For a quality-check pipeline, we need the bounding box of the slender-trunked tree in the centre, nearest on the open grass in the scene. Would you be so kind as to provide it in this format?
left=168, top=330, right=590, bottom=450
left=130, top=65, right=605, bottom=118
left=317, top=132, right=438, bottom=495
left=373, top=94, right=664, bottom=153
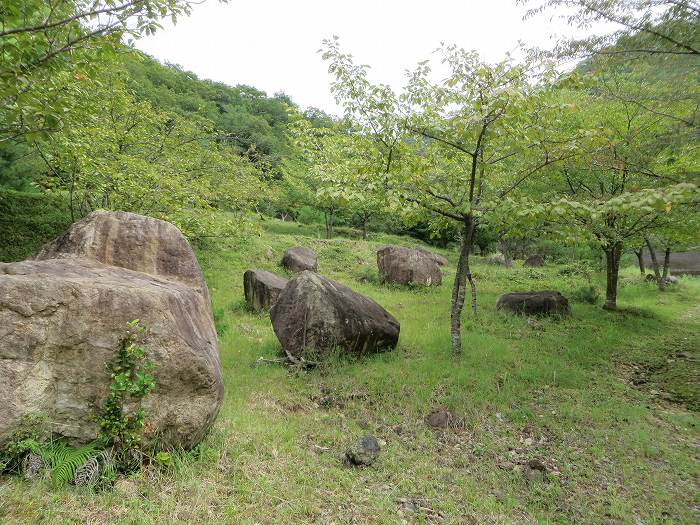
left=324, top=39, right=575, bottom=353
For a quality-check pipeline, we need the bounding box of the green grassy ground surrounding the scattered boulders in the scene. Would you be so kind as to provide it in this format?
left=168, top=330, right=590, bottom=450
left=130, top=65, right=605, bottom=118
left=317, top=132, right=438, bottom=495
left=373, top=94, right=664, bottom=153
left=0, top=216, right=700, bottom=525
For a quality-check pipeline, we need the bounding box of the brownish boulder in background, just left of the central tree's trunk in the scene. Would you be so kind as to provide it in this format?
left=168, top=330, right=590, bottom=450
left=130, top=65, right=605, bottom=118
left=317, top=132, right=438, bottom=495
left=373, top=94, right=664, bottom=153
left=377, top=246, right=442, bottom=286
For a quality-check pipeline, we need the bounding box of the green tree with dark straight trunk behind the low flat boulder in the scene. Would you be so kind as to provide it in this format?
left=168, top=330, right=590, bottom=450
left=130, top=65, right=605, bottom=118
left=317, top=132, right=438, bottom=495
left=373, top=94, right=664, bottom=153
left=502, top=78, right=698, bottom=310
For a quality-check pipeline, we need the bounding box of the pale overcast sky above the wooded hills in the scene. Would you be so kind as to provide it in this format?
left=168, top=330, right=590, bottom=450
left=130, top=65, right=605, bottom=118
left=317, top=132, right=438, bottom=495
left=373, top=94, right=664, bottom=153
left=137, top=0, right=571, bottom=114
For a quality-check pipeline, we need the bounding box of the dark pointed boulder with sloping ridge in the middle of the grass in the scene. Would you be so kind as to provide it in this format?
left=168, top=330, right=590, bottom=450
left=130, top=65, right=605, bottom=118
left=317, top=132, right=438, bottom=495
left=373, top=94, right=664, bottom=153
left=270, top=271, right=400, bottom=356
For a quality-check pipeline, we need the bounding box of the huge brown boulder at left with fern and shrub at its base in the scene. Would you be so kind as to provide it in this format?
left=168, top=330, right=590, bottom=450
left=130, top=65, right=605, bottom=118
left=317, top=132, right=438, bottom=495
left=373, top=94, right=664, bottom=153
left=0, top=212, right=223, bottom=448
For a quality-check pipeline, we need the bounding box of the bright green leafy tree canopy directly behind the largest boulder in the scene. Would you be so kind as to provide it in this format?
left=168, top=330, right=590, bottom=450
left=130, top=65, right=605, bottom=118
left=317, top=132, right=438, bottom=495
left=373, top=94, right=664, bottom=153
left=33, top=62, right=263, bottom=236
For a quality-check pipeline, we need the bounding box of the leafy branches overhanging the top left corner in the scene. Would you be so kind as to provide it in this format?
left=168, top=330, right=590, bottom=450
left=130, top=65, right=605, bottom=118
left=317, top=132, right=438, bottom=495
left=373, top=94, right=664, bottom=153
left=0, top=0, right=202, bottom=142
